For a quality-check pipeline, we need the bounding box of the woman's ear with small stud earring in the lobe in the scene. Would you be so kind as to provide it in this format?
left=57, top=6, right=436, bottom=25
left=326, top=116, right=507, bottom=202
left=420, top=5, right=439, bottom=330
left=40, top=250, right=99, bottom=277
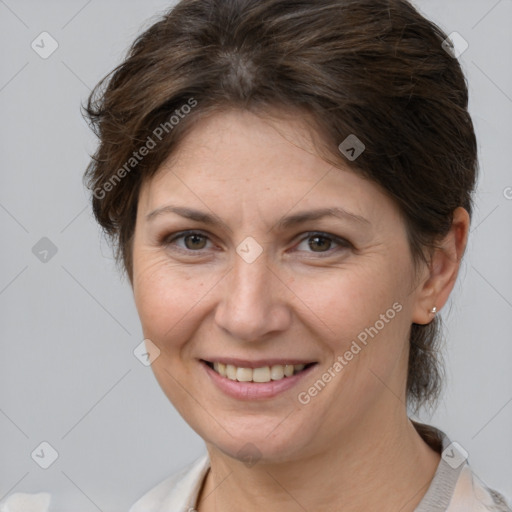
left=412, top=207, right=469, bottom=324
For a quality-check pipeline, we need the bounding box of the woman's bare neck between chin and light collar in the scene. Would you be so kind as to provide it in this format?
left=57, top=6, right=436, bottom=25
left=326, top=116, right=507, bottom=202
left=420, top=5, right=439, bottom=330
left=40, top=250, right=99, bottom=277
left=197, top=408, right=440, bottom=512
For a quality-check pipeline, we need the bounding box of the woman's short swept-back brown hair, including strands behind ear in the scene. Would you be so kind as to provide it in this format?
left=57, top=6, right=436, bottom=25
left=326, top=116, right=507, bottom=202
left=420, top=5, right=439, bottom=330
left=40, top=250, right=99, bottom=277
left=85, top=0, right=477, bottom=410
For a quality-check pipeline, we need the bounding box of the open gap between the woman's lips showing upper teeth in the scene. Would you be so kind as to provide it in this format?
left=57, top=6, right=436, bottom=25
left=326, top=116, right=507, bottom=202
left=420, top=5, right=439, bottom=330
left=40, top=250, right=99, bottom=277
left=202, top=360, right=317, bottom=383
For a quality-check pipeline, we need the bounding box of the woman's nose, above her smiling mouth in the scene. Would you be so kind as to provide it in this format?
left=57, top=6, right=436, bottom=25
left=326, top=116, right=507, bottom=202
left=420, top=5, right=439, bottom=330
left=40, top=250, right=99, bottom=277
left=215, top=252, right=292, bottom=341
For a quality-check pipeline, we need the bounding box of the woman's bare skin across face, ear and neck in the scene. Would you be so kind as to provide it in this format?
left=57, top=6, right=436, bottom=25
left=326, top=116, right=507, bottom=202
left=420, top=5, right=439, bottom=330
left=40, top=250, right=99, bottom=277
left=132, top=110, right=469, bottom=512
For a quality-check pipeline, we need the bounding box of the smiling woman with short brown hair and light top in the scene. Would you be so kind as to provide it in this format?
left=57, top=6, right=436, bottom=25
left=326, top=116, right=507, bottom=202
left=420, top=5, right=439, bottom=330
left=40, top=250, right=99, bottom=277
left=80, top=0, right=511, bottom=512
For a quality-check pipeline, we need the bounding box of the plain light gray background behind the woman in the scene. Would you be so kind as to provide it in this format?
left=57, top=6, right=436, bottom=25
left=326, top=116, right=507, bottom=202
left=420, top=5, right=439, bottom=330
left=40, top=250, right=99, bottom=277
left=0, top=0, right=512, bottom=512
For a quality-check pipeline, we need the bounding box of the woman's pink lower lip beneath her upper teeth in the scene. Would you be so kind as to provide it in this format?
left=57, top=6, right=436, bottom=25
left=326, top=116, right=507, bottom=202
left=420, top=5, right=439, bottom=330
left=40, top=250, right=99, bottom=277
left=200, top=362, right=316, bottom=400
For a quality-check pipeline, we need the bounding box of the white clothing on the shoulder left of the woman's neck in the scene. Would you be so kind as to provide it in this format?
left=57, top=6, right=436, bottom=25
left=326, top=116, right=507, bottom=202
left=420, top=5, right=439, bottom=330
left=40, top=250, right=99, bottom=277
left=129, top=455, right=209, bottom=512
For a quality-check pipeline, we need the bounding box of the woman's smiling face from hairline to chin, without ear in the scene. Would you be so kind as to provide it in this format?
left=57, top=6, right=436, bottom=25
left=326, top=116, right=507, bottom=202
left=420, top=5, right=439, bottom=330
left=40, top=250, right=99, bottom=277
left=133, top=111, right=424, bottom=461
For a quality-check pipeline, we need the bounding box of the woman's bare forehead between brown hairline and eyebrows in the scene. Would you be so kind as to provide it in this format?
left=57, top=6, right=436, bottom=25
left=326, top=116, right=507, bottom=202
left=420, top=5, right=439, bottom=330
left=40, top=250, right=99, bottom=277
left=135, top=110, right=393, bottom=228
